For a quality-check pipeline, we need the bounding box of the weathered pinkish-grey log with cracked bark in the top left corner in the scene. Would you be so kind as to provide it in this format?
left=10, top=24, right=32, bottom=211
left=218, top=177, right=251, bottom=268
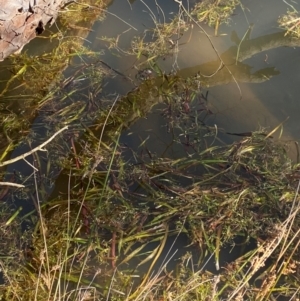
left=0, top=0, right=70, bottom=61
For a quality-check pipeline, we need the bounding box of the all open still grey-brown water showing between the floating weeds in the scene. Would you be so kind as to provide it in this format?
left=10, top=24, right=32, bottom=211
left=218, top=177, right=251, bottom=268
left=2, top=0, right=300, bottom=296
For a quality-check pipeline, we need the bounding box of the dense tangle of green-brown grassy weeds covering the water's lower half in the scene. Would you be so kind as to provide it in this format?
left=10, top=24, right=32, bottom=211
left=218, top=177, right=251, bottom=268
left=2, top=79, right=300, bottom=301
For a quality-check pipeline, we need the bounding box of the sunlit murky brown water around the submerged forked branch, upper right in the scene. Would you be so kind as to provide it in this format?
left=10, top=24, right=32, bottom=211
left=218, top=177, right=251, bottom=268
left=102, top=3, right=299, bottom=158
